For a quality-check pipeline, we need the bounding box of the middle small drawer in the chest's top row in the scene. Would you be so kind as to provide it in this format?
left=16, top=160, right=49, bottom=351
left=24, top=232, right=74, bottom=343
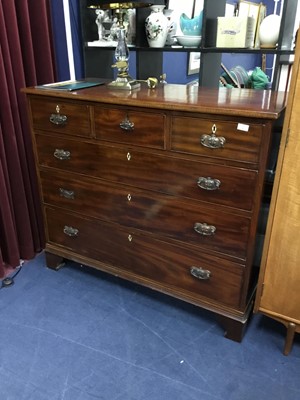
left=94, top=107, right=166, bottom=149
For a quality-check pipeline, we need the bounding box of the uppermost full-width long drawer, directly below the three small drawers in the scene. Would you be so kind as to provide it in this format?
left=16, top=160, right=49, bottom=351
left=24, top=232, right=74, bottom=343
left=36, top=135, right=257, bottom=210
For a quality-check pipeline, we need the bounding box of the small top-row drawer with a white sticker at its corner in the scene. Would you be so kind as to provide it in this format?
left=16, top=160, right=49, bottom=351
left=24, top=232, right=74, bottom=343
left=171, top=117, right=262, bottom=163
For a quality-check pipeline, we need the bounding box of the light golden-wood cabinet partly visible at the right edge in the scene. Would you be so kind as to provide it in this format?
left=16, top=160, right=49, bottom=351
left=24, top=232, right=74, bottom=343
left=255, top=35, right=300, bottom=355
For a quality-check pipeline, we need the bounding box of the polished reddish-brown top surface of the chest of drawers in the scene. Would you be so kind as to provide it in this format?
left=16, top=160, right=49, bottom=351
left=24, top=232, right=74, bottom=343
left=26, top=84, right=286, bottom=119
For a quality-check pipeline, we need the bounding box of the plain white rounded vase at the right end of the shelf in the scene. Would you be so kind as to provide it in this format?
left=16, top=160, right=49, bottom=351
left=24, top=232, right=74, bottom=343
left=259, top=14, right=281, bottom=48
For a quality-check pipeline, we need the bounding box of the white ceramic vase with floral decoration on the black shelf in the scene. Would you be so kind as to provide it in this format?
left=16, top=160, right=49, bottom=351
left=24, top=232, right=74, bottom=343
left=145, top=5, right=169, bottom=47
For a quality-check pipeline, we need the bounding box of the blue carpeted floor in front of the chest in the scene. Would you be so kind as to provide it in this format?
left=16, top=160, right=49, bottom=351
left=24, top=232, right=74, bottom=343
left=0, top=254, right=300, bottom=400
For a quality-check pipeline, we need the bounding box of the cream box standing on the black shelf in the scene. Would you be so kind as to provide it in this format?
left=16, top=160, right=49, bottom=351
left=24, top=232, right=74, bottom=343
left=216, top=17, right=255, bottom=48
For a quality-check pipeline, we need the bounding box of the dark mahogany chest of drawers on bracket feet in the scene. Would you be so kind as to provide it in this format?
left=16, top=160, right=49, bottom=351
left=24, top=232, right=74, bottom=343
left=25, top=85, right=285, bottom=341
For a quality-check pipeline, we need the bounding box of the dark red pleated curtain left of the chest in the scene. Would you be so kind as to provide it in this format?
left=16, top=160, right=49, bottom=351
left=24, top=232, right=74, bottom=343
left=0, top=0, right=55, bottom=278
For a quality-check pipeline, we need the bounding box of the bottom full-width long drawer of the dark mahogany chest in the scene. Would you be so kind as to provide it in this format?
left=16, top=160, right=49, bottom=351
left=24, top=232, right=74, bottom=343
left=46, top=208, right=244, bottom=307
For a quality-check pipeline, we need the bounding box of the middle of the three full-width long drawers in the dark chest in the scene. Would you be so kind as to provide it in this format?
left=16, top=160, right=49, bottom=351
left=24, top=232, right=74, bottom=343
left=41, top=172, right=250, bottom=259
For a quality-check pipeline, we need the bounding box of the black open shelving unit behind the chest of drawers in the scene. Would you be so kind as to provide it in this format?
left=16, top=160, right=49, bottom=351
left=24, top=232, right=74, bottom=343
left=81, top=0, right=298, bottom=90
